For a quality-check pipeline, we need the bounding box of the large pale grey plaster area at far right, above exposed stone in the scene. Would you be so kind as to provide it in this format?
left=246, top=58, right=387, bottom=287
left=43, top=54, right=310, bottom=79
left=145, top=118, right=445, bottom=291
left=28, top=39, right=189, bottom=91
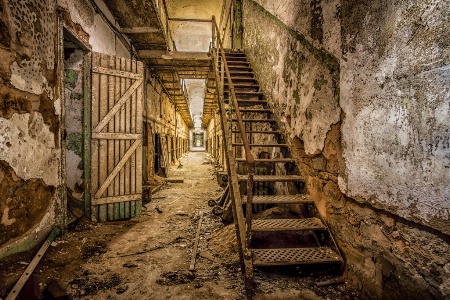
left=339, top=1, right=450, bottom=234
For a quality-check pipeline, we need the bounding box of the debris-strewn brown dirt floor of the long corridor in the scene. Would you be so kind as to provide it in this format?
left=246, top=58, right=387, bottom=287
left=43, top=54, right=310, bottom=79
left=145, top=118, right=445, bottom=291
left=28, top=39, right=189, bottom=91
left=0, top=152, right=361, bottom=300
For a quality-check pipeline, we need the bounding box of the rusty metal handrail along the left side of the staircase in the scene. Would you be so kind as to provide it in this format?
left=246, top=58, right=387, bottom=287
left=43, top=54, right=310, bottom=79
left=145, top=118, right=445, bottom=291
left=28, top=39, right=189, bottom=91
left=211, top=16, right=255, bottom=295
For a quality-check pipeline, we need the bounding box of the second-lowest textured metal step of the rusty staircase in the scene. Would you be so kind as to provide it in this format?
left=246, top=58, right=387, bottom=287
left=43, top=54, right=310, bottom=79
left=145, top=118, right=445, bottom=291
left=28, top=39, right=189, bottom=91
left=252, top=218, right=327, bottom=231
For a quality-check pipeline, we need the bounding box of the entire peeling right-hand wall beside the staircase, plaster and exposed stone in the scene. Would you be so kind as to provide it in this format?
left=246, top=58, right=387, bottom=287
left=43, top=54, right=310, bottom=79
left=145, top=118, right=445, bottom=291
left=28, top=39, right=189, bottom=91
left=243, top=0, right=450, bottom=299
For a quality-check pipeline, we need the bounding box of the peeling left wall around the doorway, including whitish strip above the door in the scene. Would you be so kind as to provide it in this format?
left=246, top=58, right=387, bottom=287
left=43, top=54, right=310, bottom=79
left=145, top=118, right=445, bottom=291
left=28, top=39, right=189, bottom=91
left=0, top=0, right=134, bottom=256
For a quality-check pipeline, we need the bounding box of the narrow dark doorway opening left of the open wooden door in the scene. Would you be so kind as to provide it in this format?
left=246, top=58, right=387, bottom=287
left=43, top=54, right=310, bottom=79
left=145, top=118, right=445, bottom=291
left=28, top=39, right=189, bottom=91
left=61, top=26, right=91, bottom=223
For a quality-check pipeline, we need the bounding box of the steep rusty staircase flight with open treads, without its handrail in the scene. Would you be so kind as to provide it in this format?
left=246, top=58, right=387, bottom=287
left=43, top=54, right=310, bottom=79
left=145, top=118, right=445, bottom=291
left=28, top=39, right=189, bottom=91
left=220, top=50, right=343, bottom=268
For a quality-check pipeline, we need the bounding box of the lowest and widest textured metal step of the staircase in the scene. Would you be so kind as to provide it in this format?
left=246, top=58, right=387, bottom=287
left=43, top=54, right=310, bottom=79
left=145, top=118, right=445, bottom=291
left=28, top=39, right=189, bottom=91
left=252, top=247, right=342, bottom=266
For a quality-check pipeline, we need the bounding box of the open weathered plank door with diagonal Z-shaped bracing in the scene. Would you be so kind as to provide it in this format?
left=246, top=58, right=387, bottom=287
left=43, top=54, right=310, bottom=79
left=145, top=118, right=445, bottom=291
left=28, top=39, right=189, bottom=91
left=91, top=53, right=144, bottom=221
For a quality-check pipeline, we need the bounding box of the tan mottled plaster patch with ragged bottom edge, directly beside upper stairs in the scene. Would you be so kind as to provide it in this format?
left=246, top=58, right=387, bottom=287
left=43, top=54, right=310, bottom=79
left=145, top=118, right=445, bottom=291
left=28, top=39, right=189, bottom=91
left=243, top=1, right=341, bottom=154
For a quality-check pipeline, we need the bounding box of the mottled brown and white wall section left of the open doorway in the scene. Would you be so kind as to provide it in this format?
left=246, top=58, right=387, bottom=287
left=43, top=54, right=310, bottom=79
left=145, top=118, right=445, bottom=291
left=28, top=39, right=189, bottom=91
left=0, top=1, right=61, bottom=253
